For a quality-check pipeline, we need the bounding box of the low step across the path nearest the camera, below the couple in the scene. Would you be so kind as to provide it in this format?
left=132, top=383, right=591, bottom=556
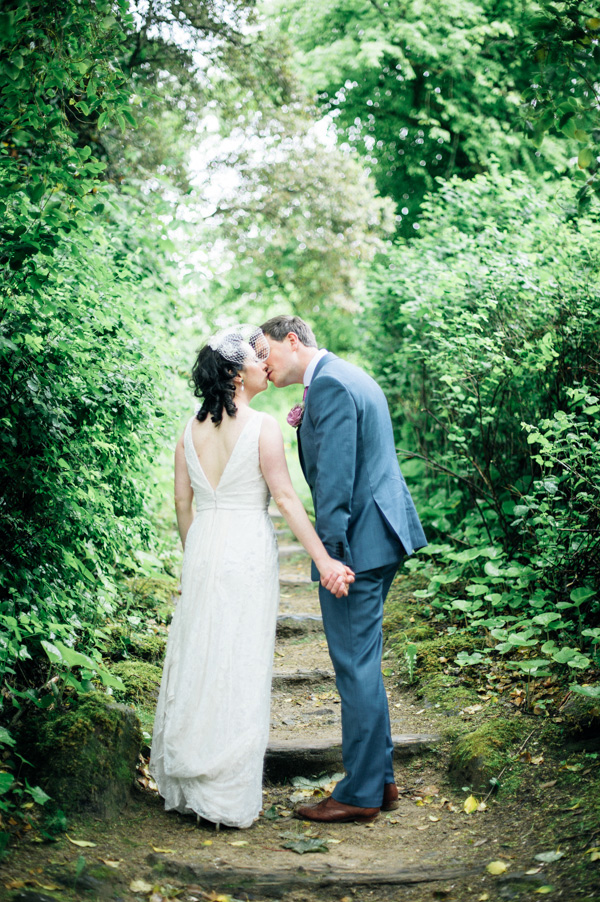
left=146, top=852, right=485, bottom=899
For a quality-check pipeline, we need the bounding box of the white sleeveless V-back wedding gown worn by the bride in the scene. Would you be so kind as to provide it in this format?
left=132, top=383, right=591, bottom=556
left=150, top=413, right=279, bottom=827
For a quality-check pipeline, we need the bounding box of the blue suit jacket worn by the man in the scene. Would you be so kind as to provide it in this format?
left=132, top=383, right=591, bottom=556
left=298, top=354, right=427, bottom=579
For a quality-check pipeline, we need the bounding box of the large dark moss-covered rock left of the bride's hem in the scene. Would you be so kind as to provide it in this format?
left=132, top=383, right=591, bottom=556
left=19, top=693, right=142, bottom=817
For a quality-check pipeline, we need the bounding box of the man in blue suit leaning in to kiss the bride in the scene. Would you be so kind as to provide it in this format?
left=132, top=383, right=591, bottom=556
left=262, top=316, right=427, bottom=823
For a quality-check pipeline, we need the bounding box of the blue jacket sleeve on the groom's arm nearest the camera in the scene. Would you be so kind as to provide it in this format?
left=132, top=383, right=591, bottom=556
left=310, top=375, right=358, bottom=567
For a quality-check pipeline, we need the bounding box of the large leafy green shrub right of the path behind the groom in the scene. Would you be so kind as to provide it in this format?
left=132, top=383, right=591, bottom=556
left=371, top=172, right=600, bottom=672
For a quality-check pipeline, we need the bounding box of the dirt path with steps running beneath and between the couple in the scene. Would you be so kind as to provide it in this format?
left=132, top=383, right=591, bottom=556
left=0, top=527, right=591, bottom=902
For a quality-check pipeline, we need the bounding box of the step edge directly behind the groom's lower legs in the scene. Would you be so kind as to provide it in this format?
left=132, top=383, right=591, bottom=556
left=264, top=733, right=441, bottom=783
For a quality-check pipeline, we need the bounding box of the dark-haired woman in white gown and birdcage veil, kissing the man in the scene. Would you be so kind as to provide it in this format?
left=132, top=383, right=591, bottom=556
left=150, top=325, right=354, bottom=827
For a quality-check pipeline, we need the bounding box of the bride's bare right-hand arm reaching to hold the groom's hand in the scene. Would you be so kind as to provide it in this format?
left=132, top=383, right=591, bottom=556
left=259, top=416, right=354, bottom=598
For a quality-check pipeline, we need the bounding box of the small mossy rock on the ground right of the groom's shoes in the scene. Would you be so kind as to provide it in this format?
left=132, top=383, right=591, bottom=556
left=448, top=717, right=530, bottom=791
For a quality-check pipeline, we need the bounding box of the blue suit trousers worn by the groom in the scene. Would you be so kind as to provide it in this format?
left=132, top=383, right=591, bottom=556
left=319, top=563, right=398, bottom=808
